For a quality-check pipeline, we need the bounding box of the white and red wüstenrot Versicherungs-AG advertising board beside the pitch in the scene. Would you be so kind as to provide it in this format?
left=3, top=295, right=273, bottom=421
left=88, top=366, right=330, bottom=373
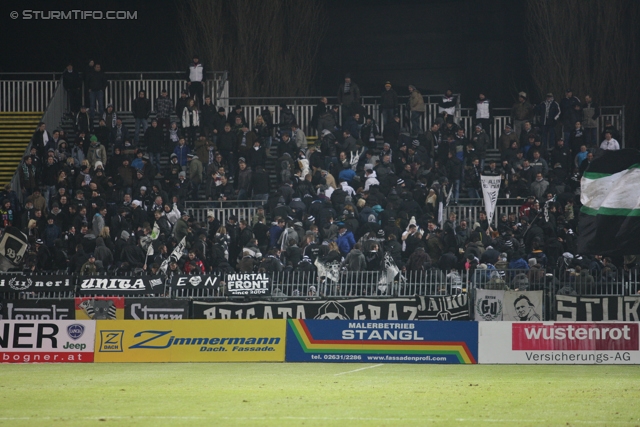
left=478, top=322, right=640, bottom=365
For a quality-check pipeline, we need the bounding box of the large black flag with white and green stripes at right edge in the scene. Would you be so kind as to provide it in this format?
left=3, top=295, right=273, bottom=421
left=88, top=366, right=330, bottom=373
left=578, top=149, right=640, bottom=256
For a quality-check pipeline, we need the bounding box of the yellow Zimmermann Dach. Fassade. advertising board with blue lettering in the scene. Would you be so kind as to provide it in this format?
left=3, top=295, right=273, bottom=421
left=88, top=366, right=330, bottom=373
left=95, top=320, right=286, bottom=362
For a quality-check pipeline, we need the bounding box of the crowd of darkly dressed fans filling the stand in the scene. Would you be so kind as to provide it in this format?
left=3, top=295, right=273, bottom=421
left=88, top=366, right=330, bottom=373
left=0, top=65, right=637, bottom=298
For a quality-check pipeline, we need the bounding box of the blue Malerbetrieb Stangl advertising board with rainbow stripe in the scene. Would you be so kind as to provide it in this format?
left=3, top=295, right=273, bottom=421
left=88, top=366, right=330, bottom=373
left=286, top=319, right=478, bottom=364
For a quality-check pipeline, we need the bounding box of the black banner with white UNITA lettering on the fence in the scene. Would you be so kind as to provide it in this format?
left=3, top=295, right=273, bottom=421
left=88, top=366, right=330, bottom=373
left=78, top=276, right=164, bottom=296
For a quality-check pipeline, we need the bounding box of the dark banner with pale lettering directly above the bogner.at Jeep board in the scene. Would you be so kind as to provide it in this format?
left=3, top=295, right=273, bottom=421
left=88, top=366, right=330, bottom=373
left=0, top=299, right=76, bottom=320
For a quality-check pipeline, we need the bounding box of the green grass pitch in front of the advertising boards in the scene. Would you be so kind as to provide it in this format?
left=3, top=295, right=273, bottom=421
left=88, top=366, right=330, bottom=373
left=0, top=363, right=640, bottom=427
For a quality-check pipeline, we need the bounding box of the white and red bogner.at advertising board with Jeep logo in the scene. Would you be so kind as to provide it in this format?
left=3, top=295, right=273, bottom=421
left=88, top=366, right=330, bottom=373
left=0, top=320, right=96, bottom=363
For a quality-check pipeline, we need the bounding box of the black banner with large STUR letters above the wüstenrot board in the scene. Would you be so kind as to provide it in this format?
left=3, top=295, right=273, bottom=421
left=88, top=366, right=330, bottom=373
left=556, top=295, right=640, bottom=322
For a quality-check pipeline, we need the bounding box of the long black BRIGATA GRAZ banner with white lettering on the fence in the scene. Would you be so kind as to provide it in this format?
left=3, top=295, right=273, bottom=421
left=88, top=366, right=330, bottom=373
left=192, top=295, right=470, bottom=320
